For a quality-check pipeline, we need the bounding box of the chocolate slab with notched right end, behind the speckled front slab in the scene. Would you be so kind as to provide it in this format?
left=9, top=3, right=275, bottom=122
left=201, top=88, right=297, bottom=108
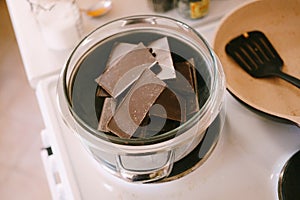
left=97, top=43, right=156, bottom=98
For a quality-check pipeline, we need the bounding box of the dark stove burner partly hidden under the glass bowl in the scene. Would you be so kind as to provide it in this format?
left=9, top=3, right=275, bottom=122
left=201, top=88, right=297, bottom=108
left=159, top=116, right=221, bottom=183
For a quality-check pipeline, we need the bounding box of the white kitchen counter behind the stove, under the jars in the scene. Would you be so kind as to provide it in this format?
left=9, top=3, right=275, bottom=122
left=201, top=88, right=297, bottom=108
left=6, top=0, right=245, bottom=88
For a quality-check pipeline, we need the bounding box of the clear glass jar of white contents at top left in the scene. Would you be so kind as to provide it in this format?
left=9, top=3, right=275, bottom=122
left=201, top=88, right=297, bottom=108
left=27, top=0, right=83, bottom=50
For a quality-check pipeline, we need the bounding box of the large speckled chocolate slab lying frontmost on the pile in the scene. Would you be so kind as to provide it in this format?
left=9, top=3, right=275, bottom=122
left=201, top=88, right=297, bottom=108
left=108, top=69, right=166, bottom=138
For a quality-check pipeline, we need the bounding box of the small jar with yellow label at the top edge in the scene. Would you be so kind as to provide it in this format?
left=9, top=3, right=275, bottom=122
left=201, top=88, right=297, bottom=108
left=177, top=0, right=210, bottom=19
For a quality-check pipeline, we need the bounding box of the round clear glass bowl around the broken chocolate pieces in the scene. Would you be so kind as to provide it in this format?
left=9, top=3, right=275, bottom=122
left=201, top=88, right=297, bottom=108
left=58, top=15, right=225, bottom=183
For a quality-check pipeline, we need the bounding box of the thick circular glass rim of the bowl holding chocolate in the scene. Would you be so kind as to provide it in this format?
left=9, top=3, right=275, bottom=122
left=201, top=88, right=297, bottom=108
left=59, top=15, right=225, bottom=146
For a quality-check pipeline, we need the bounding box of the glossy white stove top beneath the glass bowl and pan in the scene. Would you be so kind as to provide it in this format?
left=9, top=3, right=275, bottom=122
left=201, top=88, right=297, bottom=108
left=37, top=76, right=300, bottom=200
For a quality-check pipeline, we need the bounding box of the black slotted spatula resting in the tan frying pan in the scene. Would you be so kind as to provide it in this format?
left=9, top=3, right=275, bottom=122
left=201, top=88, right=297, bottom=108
left=225, top=31, right=300, bottom=88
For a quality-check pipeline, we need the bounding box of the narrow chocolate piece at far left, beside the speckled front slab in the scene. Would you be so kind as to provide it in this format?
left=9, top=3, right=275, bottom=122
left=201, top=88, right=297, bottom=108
left=98, top=98, right=117, bottom=132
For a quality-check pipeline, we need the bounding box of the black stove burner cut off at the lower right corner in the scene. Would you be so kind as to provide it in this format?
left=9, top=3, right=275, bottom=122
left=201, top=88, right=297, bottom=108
left=278, top=151, right=300, bottom=200
